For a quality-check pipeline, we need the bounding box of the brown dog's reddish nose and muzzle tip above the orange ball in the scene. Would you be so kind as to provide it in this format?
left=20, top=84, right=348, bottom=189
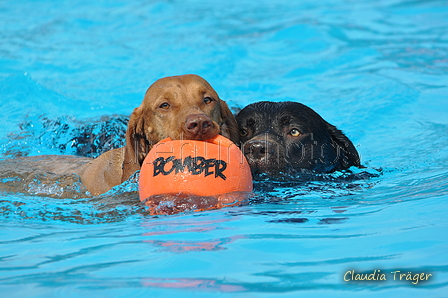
left=183, top=114, right=218, bottom=140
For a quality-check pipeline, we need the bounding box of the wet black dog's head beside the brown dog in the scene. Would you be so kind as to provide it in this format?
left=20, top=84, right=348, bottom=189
left=236, top=102, right=360, bottom=176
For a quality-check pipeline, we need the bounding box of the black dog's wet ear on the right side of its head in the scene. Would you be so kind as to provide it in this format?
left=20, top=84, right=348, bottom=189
left=325, top=121, right=361, bottom=169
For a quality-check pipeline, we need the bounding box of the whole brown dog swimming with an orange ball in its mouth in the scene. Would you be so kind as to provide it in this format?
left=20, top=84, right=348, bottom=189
left=0, top=75, right=239, bottom=195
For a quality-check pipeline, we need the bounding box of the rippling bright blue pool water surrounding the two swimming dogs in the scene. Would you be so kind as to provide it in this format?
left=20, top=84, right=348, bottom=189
left=0, top=0, right=448, bottom=297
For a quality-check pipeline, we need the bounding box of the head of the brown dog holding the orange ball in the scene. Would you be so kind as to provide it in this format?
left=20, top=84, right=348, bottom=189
left=122, top=75, right=239, bottom=181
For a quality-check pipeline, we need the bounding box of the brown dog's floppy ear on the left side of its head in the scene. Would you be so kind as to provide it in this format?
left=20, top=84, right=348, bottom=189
left=121, top=106, right=151, bottom=182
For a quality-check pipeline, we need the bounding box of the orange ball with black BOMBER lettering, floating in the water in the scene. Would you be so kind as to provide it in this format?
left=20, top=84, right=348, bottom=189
left=139, top=135, right=253, bottom=201
